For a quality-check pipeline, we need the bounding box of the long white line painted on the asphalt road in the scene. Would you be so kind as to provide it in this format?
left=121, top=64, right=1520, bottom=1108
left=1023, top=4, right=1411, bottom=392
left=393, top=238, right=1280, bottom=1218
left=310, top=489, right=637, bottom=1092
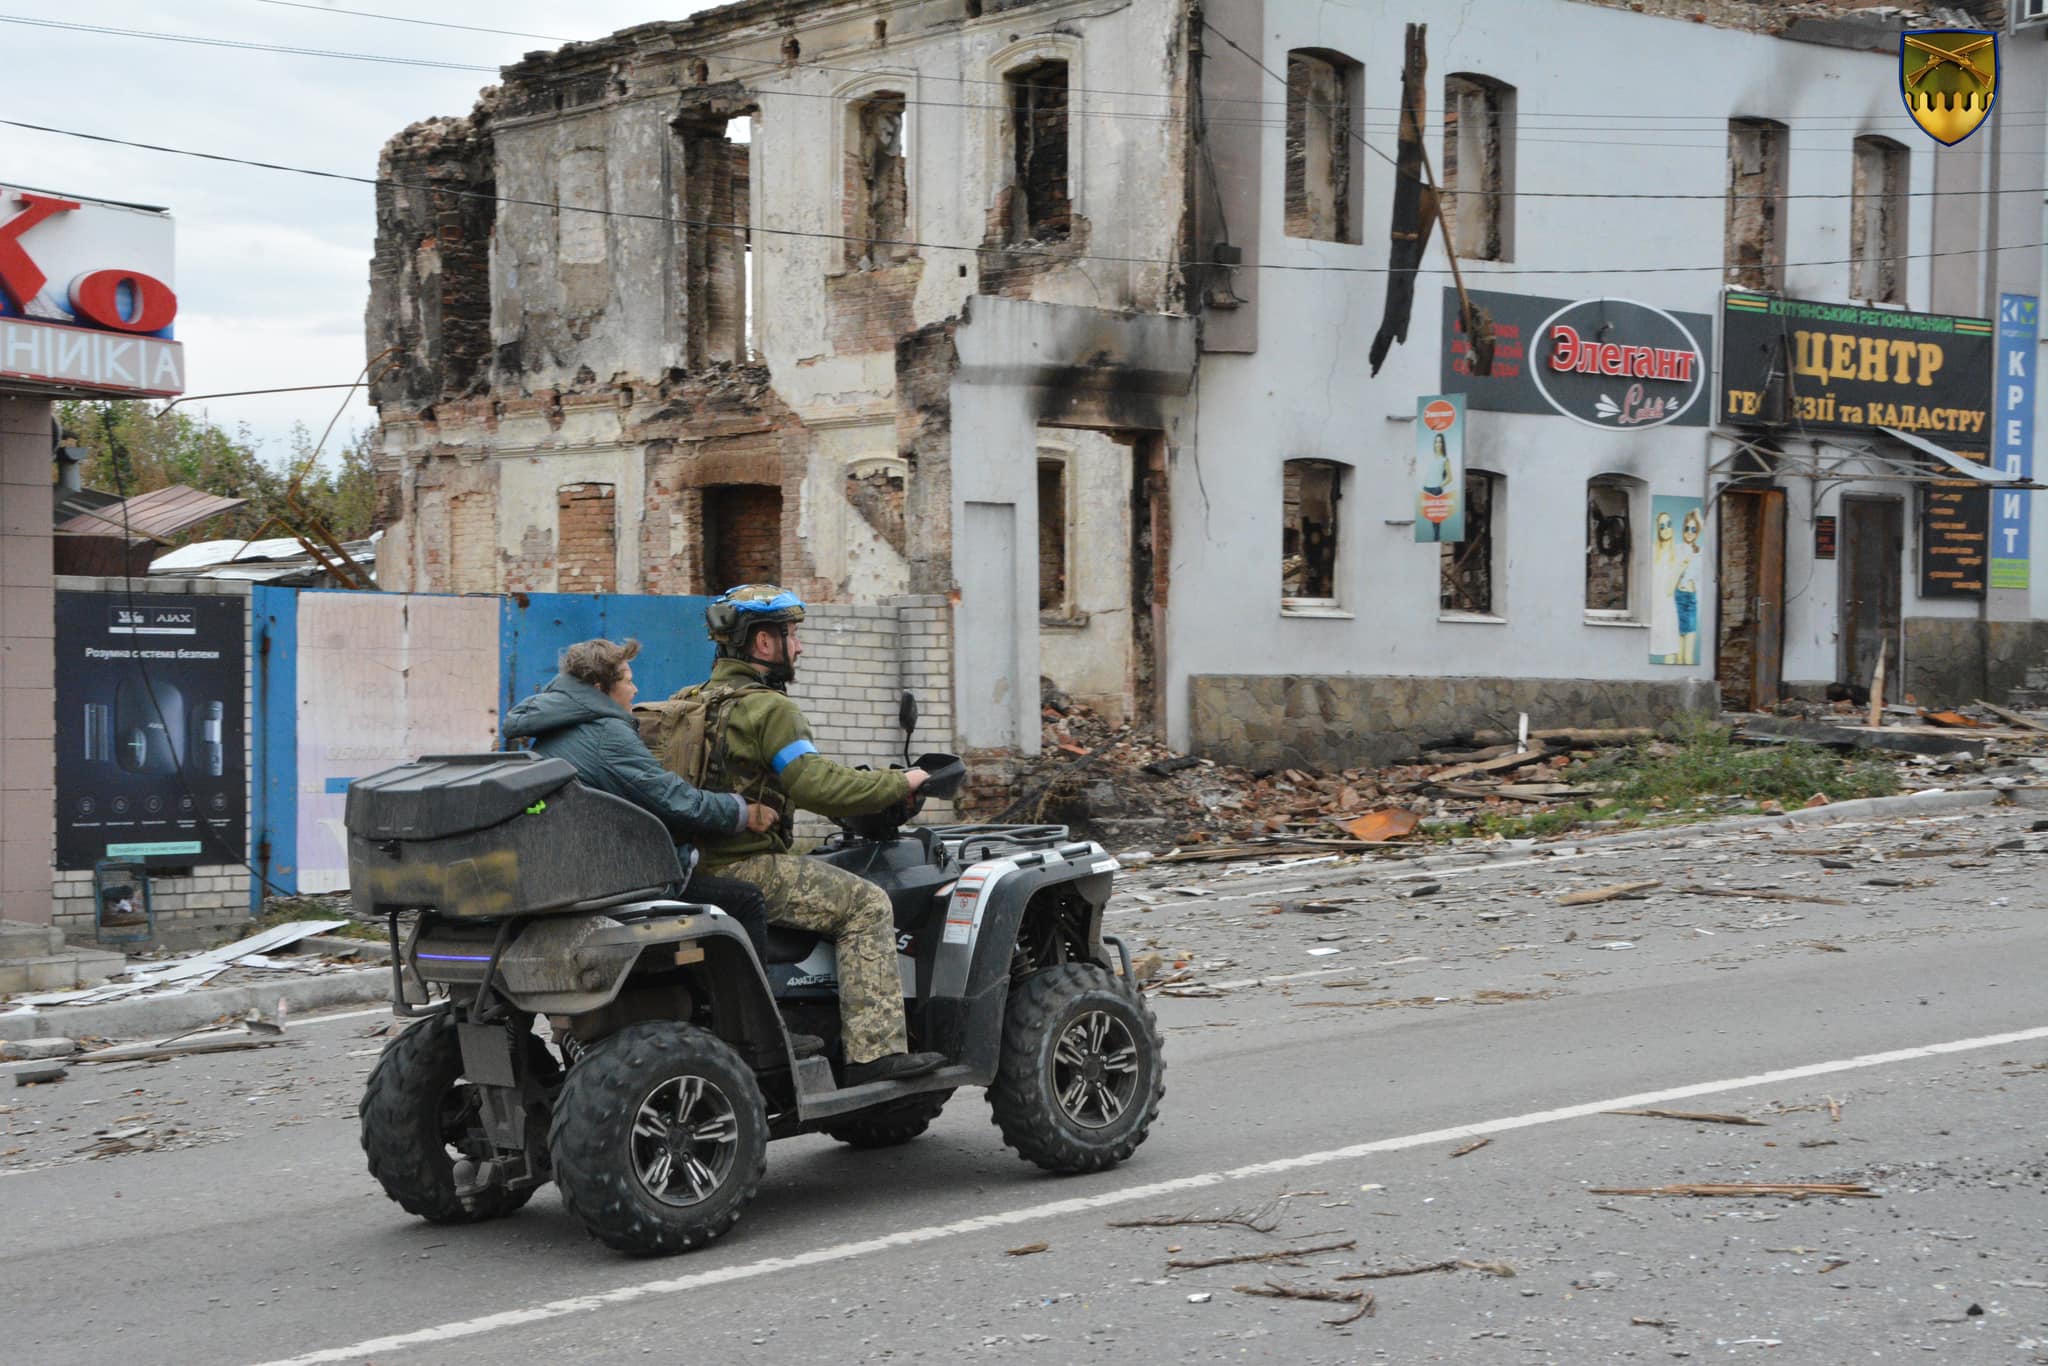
left=251, top=1026, right=2048, bottom=1366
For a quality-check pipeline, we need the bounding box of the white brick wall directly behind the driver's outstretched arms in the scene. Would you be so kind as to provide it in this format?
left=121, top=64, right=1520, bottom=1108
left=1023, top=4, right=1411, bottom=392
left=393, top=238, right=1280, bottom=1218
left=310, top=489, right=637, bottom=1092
left=788, top=594, right=956, bottom=840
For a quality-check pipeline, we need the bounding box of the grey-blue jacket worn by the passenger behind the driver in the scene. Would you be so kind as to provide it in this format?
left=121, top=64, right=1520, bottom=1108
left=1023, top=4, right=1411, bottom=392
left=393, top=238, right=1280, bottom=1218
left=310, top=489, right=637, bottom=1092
left=506, top=674, right=748, bottom=838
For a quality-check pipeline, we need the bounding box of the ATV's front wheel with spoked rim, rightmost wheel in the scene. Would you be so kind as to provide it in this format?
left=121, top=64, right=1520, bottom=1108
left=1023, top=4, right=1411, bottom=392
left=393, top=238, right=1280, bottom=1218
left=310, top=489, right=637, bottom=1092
left=989, top=963, right=1165, bottom=1171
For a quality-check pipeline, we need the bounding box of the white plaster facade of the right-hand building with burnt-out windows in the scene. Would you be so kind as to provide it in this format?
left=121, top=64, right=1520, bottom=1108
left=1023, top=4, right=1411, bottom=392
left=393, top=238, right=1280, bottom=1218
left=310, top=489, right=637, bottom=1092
left=1167, top=0, right=2007, bottom=743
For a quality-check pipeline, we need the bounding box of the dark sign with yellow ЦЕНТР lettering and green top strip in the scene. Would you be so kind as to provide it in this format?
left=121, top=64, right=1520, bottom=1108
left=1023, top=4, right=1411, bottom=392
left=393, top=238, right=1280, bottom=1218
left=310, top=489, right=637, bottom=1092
left=1720, top=291, right=1993, bottom=446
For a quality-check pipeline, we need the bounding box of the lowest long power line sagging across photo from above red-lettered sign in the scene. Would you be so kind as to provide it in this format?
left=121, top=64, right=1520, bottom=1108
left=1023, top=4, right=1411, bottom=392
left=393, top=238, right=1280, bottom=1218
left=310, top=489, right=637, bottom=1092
left=0, top=119, right=2048, bottom=279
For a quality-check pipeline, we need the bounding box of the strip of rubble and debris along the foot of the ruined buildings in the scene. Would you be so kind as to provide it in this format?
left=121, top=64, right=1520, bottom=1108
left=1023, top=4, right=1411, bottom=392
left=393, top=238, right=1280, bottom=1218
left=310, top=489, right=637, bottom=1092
left=989, top=680, right=2048, bottom=862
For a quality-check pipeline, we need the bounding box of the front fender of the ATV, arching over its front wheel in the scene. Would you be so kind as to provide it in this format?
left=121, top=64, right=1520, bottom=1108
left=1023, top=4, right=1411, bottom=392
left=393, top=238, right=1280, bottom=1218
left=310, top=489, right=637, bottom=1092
left=926, top=844, right=1120, bottom=1085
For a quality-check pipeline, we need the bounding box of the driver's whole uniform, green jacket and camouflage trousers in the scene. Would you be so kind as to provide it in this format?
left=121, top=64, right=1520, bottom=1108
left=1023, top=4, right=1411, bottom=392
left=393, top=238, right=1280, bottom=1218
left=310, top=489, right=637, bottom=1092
left=684, top=659, right=909, bottom=1063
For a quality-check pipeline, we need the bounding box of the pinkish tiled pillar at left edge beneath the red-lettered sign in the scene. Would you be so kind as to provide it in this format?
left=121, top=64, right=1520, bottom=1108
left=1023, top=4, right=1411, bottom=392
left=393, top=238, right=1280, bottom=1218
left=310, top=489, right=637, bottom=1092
left=0, top=397, right=57, bottom=926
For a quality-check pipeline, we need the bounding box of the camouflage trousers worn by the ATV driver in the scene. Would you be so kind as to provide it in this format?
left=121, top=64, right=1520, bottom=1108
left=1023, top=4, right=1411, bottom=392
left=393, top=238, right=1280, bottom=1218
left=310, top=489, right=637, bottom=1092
left=717, top=854, right=909, bottom=1063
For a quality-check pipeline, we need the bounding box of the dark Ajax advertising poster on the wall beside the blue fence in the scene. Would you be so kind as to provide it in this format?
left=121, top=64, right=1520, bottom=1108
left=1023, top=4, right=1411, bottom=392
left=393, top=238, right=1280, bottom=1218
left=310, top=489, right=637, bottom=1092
left=55, top=592, right=248, bottom=868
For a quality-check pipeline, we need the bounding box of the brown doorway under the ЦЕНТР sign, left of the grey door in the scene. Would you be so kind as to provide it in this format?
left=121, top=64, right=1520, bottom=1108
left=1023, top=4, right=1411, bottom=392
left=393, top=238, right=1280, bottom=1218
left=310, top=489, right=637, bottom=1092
left=1714, top=487, right=1786, bottom=711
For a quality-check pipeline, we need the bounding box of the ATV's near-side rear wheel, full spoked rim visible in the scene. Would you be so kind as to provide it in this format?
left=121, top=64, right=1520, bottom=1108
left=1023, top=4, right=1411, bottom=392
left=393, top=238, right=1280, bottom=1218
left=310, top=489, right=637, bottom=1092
left=549, top=1020, right=768, bottom=1255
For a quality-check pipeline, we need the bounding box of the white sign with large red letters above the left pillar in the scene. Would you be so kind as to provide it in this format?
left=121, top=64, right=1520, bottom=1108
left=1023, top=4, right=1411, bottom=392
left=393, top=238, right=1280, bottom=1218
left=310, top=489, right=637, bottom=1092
left=0, top=184, right=184, bottom=395
